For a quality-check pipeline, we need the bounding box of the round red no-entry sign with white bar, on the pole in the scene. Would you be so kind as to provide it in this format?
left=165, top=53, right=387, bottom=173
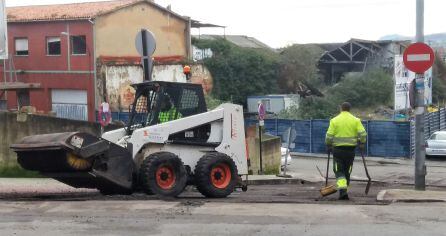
left=403, top=43, right=434, bottom=74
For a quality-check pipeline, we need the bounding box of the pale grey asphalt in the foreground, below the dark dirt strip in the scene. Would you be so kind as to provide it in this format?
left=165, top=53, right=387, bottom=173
left=0, top=200, right=446, bottom=236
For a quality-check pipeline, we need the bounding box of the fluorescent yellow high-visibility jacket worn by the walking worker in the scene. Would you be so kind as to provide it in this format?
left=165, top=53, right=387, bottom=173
left=325, top=111, right=367, bottom=147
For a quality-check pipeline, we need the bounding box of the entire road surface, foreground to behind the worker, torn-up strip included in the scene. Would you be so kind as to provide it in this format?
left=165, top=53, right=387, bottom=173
left=0, top=154, right=446, bottom=236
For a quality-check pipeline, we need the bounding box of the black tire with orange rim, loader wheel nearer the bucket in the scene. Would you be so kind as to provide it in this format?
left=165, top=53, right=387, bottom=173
left=140, top=152, right=187, bottom=197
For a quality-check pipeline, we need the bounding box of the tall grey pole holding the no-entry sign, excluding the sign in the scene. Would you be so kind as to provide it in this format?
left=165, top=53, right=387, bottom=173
left=415, top=0, right=426, bottom=190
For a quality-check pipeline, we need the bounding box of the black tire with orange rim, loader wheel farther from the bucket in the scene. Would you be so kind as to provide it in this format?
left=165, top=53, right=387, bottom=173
left=195, top=152, right=238, bottom=198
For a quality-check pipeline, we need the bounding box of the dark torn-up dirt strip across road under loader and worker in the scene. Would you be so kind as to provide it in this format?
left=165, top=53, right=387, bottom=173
left=0, top=179, right=434, bottom=207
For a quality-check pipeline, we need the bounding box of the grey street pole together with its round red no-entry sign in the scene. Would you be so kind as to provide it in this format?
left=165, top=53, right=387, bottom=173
left=403, top=0, right=434, bottom=190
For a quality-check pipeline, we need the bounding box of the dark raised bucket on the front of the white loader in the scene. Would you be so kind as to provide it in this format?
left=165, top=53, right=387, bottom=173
left=11, top=132, right=134, bottom=193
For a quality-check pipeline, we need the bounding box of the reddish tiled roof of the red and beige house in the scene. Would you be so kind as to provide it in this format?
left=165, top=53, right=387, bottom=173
left=6, top=0, right=183, bottom=22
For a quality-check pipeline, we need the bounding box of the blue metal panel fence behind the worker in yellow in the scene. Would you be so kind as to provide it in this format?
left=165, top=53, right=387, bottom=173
left=246, top=119, right=410, bottom=158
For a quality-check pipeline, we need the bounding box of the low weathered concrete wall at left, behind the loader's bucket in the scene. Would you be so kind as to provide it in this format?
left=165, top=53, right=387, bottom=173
left=0, top=112, right=100, bottom=167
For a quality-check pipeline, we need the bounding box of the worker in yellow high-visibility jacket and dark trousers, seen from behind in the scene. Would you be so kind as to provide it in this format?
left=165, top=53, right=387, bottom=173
left=325, top=102, right=367, bottom=200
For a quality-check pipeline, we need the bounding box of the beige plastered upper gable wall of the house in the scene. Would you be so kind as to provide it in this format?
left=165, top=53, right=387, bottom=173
left=95, top=2, right=188, bottom=57
